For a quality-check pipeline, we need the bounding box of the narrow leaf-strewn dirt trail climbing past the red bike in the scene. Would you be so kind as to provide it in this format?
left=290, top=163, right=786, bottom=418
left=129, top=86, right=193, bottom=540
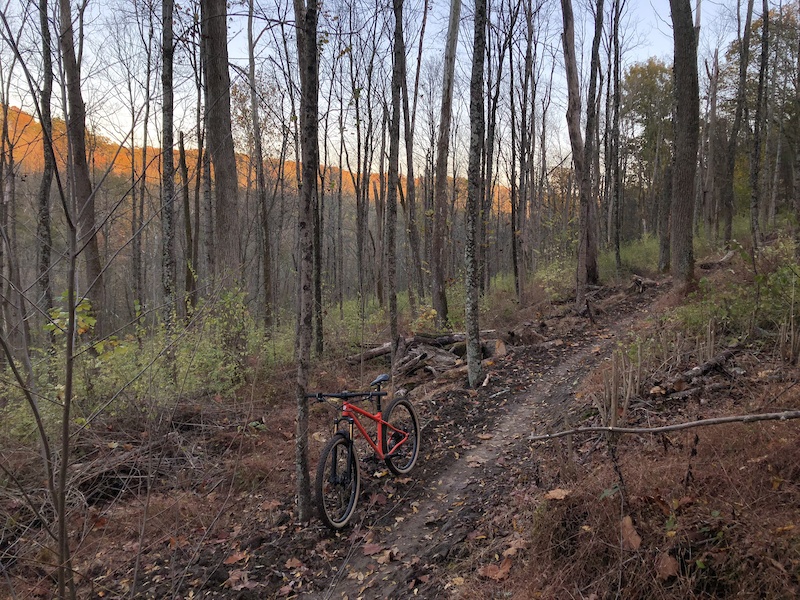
left=303, top=296, right=647, bottom=600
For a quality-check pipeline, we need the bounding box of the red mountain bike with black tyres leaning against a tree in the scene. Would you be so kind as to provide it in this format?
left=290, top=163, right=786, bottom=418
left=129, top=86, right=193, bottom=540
left=307, top=373, right=420, bottom=529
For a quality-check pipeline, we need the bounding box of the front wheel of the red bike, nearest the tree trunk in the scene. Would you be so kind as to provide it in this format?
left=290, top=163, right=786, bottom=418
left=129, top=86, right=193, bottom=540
left=315, top=433, right=361, bottom=529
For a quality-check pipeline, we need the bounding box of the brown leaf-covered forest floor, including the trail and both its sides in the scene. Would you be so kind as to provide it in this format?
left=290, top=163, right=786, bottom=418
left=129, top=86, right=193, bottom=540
left=6, top=266, right=800, bottom=600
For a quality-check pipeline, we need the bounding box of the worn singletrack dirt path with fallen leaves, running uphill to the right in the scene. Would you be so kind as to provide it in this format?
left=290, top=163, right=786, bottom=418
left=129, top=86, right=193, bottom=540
left=302, top=293, right=654, bottom=600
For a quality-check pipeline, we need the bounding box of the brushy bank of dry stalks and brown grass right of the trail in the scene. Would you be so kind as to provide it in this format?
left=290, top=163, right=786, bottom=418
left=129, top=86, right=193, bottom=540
left=505, top=229, right=800, bottom=600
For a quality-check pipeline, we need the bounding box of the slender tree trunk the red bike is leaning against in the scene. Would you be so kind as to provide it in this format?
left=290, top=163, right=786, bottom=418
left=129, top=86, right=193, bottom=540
left=294, top=0, right=319, bottom=521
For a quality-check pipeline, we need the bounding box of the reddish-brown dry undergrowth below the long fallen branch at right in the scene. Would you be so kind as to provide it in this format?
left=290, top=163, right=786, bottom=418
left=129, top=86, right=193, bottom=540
left=517, top=410, right=800, bottom=599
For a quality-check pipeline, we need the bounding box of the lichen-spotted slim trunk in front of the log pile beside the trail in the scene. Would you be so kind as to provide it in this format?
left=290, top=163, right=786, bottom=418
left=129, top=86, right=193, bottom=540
left=464, top=0, right=486, bottom=388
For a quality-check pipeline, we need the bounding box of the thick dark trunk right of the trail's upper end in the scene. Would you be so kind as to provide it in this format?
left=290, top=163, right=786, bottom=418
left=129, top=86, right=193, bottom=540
left=670, top=0, right=700, bottom=287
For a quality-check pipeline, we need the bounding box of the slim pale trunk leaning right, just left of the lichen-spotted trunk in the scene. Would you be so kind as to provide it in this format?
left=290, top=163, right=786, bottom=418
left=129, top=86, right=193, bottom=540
left=431, top=0, right=461, bottom=328
